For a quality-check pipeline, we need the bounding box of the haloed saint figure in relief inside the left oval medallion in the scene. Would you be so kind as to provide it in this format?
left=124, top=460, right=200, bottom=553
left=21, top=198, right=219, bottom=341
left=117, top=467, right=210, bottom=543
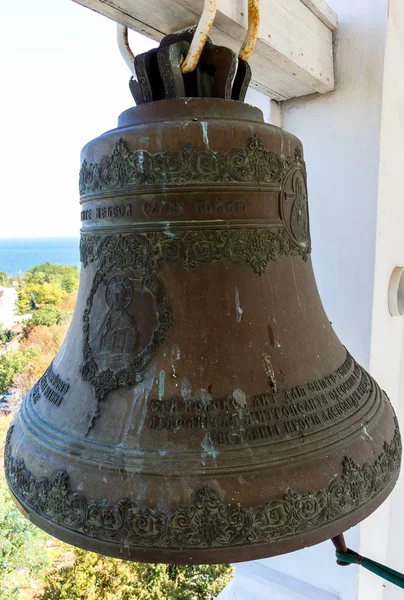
left=92, top=275, right=139, bottom=369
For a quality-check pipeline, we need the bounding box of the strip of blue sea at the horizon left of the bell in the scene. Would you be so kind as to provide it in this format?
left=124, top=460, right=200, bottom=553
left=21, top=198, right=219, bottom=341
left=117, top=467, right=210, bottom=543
left=0, top=236, right=80, bottom=283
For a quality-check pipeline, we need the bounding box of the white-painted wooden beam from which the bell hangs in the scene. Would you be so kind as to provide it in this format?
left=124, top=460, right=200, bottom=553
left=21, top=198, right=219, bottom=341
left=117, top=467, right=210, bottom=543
left=74, top=0, right=334, bottom=100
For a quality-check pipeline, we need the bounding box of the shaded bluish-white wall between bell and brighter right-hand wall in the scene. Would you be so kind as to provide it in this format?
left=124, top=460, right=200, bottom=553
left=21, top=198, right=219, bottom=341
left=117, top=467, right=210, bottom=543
left=283, top=0, right=387, bottom=367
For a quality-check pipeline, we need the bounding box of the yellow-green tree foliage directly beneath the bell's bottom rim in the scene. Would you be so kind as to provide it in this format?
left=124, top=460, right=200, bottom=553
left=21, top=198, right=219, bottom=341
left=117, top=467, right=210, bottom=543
left=40, top=549, right=232, bottom=600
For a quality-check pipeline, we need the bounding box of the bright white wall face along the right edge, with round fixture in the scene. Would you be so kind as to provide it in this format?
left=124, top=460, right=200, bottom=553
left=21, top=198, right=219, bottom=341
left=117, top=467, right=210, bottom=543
left=370, top=0, right=404, bottom=600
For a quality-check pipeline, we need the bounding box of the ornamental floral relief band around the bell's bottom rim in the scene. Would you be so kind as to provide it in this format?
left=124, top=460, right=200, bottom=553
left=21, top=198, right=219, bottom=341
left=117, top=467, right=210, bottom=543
left=5, top=423, right=401, bottom=549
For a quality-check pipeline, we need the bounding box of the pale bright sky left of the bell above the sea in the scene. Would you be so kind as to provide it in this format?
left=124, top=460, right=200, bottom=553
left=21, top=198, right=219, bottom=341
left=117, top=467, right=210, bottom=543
left=0, top=0, right=155, bottom=238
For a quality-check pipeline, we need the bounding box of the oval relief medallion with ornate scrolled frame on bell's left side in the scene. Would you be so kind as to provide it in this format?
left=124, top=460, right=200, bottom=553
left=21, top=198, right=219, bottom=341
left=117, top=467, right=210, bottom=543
left=81, top=235, right=172, bottom=424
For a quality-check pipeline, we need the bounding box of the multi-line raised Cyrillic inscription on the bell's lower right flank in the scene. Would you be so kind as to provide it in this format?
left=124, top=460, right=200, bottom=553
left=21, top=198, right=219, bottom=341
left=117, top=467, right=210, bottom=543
left=148, top=354, right=371, bottom=445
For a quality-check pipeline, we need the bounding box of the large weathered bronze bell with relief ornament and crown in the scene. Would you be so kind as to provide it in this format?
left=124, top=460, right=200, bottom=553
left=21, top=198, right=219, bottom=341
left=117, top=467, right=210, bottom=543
left=5, top=34, right=401, bottom=563
